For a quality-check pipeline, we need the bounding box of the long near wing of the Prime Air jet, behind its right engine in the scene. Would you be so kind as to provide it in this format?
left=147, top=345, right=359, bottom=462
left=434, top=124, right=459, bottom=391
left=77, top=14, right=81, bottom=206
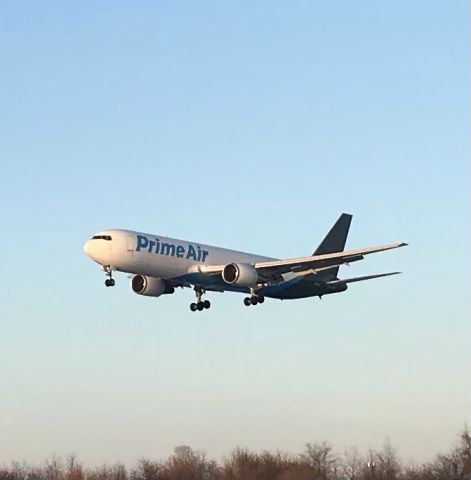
left=198, top=243, right=407, bottom=281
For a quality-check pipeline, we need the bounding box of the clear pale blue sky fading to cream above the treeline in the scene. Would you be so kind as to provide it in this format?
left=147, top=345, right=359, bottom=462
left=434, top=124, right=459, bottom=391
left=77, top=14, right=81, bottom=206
left=0, top=0, right=471, bottom=464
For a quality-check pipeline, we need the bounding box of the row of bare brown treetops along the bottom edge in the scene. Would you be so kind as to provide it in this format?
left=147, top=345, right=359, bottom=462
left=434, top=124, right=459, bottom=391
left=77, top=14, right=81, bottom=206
left=0, top=429, right=471, bottom=480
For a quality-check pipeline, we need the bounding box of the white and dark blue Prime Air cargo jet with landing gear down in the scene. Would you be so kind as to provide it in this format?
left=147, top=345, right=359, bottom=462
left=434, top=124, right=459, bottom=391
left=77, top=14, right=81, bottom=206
left=84, top=213, right=407, bottom=312
